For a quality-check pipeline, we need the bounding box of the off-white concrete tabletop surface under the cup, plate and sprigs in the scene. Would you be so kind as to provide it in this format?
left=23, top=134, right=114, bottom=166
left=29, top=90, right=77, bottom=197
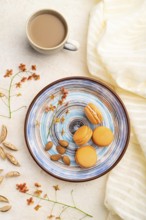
left=0, top=0, right=107, bottom=220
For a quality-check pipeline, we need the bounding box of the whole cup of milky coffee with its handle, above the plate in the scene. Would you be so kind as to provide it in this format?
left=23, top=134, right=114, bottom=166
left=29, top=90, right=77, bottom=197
left=26, top=9, right=78, bottom=54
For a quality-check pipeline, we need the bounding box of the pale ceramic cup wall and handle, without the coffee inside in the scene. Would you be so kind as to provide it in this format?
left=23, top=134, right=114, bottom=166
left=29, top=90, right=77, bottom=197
left=26, top=9, right=79, bottom=55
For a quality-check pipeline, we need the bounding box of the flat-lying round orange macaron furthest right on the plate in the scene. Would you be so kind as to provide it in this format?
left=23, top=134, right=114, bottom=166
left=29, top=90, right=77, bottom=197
left=92, top=126, right=114, bottom=147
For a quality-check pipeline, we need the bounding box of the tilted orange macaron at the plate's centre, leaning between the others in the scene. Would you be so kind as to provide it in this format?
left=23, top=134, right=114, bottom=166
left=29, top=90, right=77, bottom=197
left=73, top=125, right=93, bottom=146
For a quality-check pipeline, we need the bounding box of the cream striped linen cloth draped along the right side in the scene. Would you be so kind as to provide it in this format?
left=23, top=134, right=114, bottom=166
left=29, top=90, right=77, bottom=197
left=87, top=0, right=146, bottom=220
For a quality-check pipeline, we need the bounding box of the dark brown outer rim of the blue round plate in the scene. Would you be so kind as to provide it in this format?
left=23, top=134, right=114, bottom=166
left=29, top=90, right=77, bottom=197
left=24, top=76, right=131, bottom=183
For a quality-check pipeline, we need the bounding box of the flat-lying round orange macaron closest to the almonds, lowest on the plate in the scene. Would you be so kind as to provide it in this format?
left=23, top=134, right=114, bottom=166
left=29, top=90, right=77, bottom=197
left=75, top=145, right=97, bottom=168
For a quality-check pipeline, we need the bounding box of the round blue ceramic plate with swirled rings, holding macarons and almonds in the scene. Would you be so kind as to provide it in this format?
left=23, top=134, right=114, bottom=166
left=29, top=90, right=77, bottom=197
left=25, top=77, right=130, bottom=182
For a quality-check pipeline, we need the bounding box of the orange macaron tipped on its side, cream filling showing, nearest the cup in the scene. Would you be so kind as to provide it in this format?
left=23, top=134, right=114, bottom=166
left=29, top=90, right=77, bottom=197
left=84, top=103, right=103, bottom=124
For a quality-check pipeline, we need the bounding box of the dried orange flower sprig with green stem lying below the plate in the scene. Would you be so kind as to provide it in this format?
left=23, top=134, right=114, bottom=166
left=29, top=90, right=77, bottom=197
left=16, top=183, right=93, bottom=219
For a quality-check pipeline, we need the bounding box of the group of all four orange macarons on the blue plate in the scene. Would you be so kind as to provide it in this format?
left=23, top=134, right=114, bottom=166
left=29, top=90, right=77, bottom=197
left=73, top=103, right=114, bottom=168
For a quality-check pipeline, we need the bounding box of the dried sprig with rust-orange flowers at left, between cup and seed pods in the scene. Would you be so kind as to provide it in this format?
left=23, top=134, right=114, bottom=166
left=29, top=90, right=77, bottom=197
left=0, top=63, right=40, bottom=118
